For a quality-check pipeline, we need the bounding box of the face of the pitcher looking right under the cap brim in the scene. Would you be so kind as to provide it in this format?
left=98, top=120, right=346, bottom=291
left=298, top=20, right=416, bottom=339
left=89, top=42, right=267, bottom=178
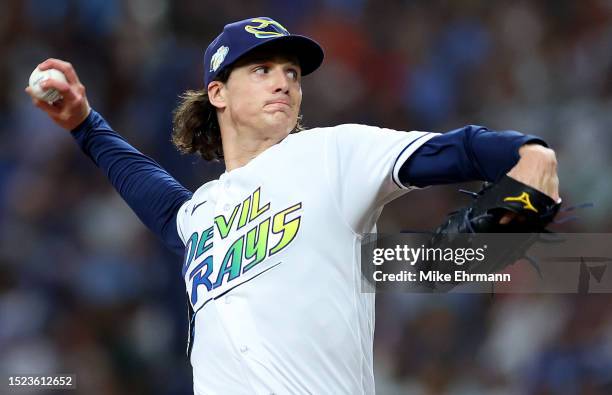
left=209, top=52, right=302, bottom=139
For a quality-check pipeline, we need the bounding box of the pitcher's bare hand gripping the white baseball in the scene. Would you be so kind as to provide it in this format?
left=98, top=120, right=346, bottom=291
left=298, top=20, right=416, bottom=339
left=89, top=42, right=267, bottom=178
left=25, top=59, right=91, bottom=130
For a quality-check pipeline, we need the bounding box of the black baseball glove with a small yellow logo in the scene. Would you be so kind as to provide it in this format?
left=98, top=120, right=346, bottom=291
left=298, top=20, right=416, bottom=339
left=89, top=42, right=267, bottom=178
left=417, top=176, right=561, bottom=292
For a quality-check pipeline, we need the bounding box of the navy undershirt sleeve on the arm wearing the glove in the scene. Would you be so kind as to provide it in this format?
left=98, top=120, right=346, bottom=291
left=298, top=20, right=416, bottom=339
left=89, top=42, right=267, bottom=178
left=399, top=125, right=548, bottom=187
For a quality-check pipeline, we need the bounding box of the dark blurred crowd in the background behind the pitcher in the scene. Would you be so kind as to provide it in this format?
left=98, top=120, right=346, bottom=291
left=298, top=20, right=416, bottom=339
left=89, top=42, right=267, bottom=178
left=0, top=0, right=612, bottom=395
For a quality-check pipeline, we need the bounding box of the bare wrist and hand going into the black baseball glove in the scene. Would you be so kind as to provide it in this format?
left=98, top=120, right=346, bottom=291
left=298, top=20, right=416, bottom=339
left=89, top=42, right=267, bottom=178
left=499, top=144, right=561, bottom=225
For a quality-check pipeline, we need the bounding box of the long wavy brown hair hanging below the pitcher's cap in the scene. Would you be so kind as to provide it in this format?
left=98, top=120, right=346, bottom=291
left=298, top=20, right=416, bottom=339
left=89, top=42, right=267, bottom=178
left=172, top=67, right=304, bottom=161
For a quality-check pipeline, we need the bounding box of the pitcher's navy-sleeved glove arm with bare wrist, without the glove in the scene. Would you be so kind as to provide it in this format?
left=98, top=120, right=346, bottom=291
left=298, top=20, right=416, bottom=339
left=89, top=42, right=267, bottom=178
left=399, top=126, right=559, bottom=201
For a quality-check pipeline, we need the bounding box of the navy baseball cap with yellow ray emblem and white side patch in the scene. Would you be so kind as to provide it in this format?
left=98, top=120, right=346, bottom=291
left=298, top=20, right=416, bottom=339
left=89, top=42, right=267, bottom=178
left=204, top=17, right=324, bottom=88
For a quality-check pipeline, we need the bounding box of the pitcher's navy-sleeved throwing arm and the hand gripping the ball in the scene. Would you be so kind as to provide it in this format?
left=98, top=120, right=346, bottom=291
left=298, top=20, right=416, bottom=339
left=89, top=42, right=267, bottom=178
left=26, top=59, right=191, bottom=255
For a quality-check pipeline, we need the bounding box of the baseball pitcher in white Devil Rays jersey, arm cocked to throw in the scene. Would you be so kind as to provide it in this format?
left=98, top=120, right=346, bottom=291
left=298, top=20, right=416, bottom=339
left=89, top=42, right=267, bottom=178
left=28, top=17, right=560, bottom=394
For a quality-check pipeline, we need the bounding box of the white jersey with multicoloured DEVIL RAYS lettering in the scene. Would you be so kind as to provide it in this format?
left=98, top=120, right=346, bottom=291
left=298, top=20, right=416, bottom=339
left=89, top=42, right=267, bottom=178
left=177, top=124, right=436, bottom=394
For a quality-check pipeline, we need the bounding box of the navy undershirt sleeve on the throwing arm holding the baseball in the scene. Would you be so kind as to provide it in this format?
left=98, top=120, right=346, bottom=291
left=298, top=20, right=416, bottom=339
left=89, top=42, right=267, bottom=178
left=72, top=110, right=192, bottom=255
